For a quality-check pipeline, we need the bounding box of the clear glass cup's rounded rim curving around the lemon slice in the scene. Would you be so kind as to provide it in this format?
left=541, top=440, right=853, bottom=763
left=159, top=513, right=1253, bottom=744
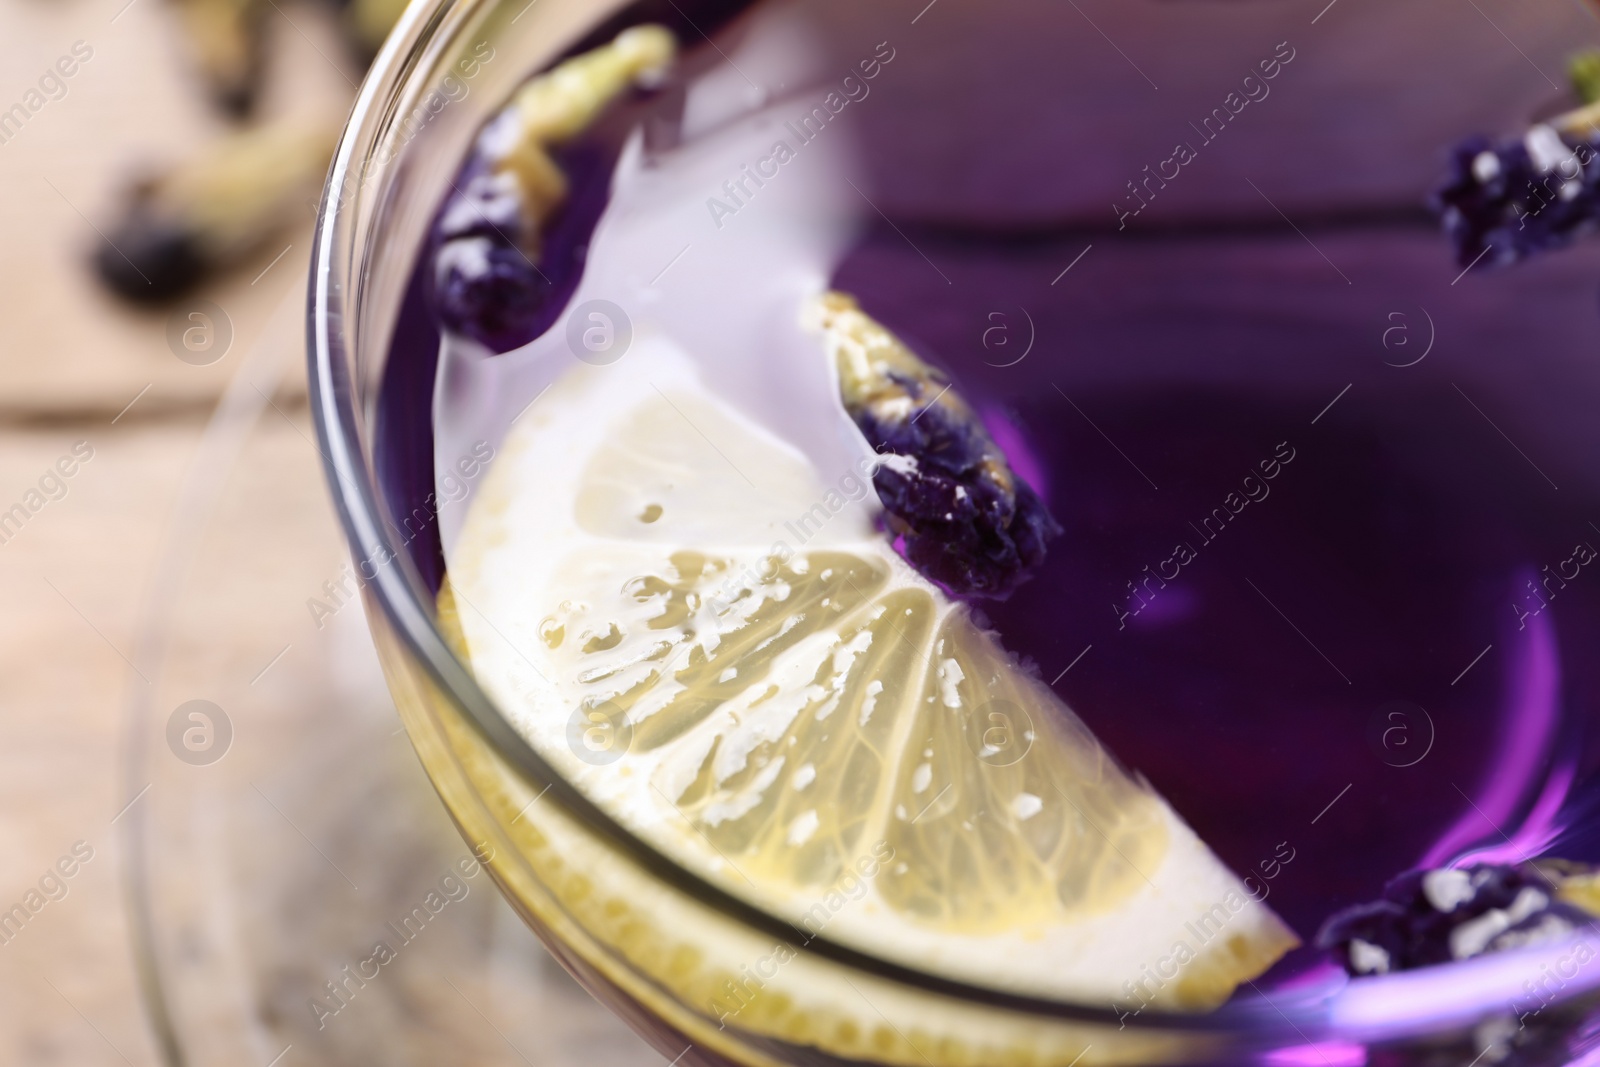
left=297, top=0, right=1600, bottom=1048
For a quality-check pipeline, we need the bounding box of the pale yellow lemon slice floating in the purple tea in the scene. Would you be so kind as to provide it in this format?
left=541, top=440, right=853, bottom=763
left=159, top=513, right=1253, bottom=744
left=450, top=331, right=1296, bottom=1009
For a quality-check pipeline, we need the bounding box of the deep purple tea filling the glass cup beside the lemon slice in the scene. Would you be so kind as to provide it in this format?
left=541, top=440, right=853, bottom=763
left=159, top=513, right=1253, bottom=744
left=378, top=2, right=1600, bottom=987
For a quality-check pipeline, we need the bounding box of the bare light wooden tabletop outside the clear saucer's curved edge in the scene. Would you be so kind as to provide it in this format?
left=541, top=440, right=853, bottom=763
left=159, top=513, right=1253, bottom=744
left=0, top=0, right=360, bottom=1067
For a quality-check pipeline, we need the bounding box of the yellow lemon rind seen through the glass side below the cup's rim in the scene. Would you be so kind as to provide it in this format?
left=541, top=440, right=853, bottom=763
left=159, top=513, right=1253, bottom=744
left=373, top=601, right=1203, bottom=1067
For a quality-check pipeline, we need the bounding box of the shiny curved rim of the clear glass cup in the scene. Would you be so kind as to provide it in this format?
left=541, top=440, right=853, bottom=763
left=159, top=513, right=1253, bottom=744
left=307, top=0, right=1600, bottom=1049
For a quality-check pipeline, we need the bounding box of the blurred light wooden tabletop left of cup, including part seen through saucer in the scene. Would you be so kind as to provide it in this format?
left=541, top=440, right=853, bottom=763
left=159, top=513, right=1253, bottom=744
left=0, top=0, right=658, bottom=1067
